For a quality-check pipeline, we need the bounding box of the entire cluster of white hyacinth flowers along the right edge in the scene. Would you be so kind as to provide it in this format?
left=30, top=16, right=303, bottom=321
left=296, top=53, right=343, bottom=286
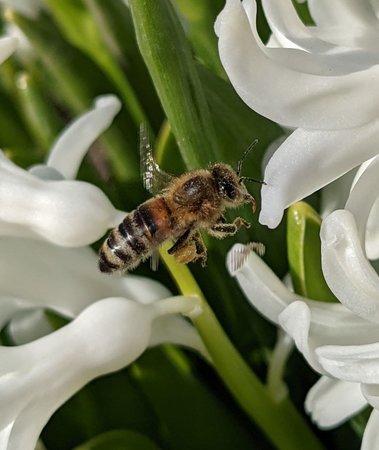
left=216, top=0, right=379, bottom=450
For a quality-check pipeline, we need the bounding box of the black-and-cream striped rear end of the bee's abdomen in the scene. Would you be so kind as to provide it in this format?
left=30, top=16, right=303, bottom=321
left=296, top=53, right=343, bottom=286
left=99, top=209, right=152, bottom=273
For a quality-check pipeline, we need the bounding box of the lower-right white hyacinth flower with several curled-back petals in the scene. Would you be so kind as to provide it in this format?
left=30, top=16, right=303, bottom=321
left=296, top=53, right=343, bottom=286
left=227, top=204, right=379, bottom=450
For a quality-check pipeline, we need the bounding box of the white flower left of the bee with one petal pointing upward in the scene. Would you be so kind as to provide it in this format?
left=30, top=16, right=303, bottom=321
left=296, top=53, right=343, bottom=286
left=0, top=95, right=123, bottom=247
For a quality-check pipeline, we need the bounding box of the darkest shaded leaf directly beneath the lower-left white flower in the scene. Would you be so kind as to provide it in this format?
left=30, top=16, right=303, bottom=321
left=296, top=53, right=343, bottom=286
left=42, top=370, right=160, bottom=450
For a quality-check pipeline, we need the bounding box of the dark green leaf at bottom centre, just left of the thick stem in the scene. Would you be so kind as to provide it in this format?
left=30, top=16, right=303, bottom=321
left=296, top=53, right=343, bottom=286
left=131, top=346, right=264, bottom=450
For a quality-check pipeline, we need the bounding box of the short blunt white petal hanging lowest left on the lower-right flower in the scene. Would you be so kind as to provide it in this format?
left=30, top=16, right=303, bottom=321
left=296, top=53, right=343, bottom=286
left=305, top=376, right=367, bottom=429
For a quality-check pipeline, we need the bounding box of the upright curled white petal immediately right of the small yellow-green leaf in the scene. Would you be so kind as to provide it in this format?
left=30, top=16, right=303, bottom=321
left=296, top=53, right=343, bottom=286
left=320, top=210, right=379, bottom=323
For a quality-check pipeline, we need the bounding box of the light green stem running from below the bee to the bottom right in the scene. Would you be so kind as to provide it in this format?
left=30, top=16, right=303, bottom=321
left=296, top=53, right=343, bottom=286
left=160, top=244, right=323, bottom=450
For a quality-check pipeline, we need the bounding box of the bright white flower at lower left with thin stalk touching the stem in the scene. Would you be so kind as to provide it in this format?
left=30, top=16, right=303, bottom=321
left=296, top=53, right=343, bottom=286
left=0, top=297, right=202, bottom=450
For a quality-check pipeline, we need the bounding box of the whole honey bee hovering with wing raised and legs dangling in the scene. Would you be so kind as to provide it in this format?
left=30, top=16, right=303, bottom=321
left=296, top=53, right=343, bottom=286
left=99, top=126, right=264, bottom=273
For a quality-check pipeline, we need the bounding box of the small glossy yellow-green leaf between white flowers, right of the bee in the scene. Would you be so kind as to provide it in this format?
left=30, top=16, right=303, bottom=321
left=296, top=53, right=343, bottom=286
left=287, top=202, right=338, bottom=302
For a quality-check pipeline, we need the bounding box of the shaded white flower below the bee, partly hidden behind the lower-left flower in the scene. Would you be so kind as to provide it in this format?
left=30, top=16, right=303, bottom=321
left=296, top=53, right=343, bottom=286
left=0, top=238, right=207, bottom=356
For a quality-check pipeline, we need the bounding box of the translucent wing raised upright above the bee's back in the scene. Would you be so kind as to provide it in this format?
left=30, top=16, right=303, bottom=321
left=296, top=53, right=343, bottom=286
left=140, top=124, right=175, bottom=195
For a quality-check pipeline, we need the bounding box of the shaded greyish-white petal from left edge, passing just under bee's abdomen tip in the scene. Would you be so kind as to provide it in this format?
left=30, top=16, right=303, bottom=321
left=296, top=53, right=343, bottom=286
left=0, top=238, right=170, bottom=321
